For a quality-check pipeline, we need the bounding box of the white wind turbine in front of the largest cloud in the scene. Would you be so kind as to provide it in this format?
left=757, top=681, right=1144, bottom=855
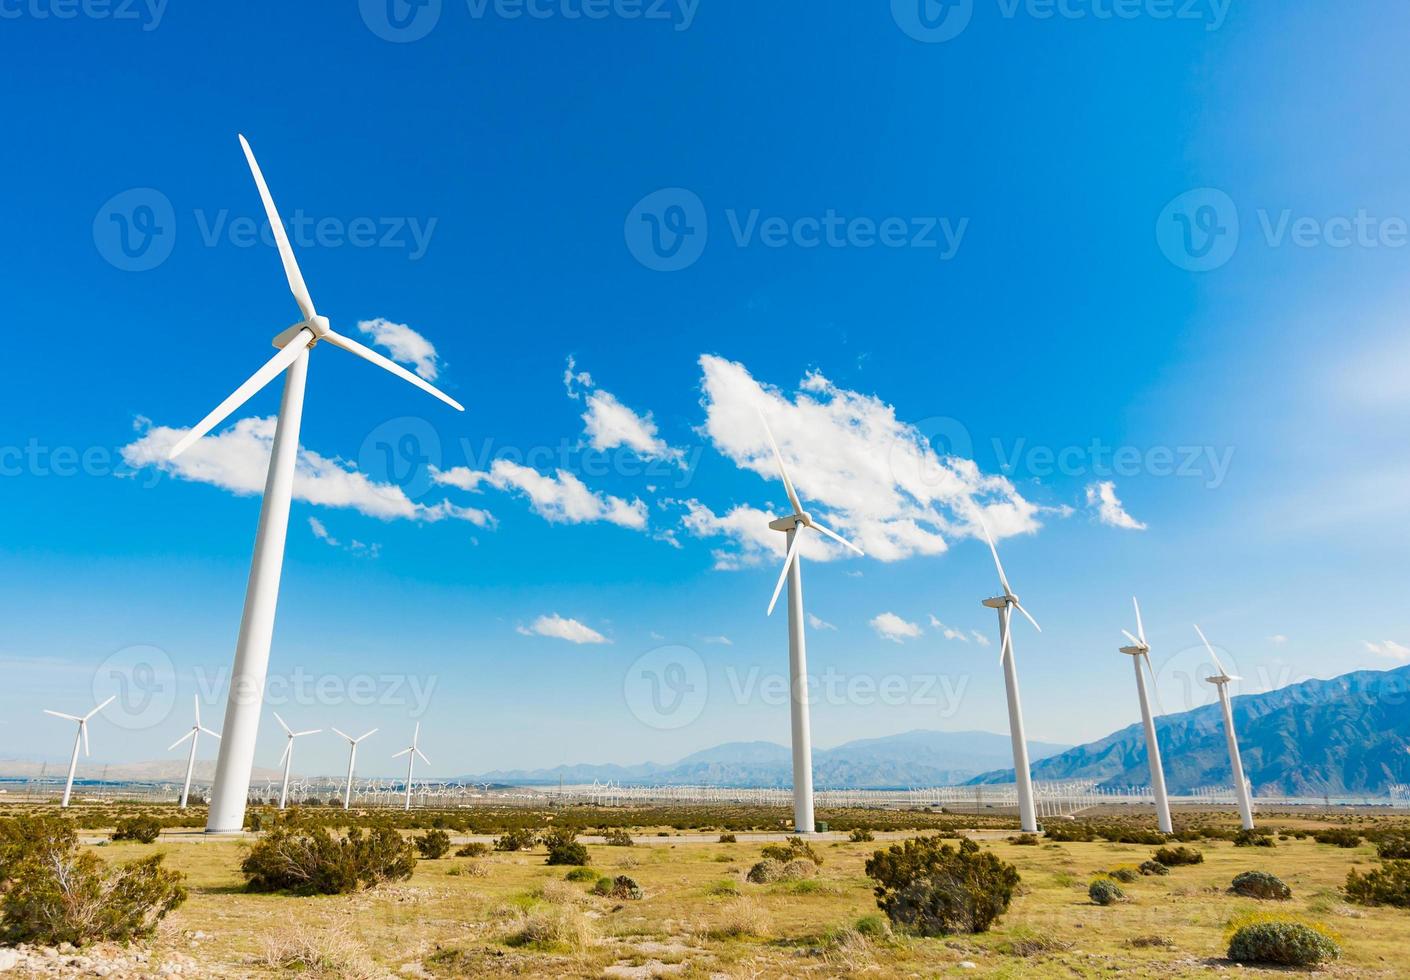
left=759, top=412, right=863, bottom=833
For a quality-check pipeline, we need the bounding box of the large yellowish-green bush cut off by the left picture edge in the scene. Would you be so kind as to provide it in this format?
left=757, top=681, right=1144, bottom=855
left=0, top=816, right=186, bottom=946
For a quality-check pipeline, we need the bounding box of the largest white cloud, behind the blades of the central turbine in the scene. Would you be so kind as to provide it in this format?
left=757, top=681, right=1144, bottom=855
left=685, top=354, right=1039, bottom=567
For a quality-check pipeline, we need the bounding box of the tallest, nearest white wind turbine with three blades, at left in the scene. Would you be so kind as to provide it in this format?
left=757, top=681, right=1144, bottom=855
left=171, top=135, right=464, bottom=833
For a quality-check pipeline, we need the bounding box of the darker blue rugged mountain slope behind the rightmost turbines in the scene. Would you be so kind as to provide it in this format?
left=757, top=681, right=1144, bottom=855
left=973, top=666, right=1410, bottom=797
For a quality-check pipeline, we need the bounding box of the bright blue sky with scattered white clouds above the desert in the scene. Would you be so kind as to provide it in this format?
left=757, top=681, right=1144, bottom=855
left=0, top=0, right=1410, bottom=774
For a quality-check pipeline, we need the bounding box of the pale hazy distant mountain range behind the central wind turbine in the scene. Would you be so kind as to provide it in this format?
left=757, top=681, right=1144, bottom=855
left=465, top=730, right=1067, bottom=790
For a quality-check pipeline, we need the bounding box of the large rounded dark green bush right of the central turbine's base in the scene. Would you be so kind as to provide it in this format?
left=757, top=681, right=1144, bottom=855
left=866, top=836, right=1019, bottom=936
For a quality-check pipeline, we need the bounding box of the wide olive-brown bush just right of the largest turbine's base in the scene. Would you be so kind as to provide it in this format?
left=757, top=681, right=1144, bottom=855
left=240, top=822, right=416, bottom=895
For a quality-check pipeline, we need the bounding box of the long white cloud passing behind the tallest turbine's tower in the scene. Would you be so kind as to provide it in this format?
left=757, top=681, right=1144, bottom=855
left=121, top=417, right=495, bottom=527
